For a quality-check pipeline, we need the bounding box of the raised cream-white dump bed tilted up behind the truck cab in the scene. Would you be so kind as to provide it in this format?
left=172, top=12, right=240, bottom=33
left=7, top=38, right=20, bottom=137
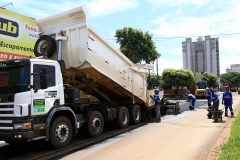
left=37, top=6, right=147, bottom=104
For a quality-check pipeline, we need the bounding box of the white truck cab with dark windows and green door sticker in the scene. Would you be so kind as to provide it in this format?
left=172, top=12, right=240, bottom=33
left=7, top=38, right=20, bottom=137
left=0, top=59, right=76, bottom=148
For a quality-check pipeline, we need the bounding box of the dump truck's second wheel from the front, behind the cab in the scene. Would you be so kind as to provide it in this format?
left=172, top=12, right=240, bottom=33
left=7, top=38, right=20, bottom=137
left=87, top=111, right=104, bottom=137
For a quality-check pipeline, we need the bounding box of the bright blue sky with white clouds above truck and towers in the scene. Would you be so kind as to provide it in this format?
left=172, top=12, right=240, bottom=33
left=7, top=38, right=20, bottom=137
left=0, top=0, right=240, bottom=74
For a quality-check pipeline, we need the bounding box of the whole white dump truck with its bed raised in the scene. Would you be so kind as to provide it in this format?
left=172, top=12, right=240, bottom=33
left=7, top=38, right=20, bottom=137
left=0, top=5, right=158, bottom=148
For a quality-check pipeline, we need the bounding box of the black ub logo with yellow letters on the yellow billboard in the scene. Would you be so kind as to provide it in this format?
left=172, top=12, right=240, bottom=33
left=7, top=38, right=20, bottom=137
left=0, top=18, right=19, bottom=37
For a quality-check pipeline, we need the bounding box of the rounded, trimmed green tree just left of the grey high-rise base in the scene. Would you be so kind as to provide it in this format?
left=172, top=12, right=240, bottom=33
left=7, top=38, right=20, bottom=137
left=160, top=68, right=195, bottom=90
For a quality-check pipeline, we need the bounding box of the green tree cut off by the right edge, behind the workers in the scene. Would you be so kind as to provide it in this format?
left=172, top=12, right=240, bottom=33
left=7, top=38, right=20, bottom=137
left=220, top=72, right=240, bottom=85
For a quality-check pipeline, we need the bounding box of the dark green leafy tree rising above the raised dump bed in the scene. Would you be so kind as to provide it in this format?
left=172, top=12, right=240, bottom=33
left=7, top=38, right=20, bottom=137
left=115, top=27, right=161, bottom=64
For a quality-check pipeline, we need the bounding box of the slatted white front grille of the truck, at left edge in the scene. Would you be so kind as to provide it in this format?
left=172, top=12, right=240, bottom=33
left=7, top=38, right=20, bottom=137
left=0, top=102, right=14, bottom=130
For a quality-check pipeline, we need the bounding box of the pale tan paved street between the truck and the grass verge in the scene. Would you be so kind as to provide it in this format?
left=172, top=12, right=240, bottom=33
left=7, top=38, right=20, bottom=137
left=63, top=93, right=240, bottom=160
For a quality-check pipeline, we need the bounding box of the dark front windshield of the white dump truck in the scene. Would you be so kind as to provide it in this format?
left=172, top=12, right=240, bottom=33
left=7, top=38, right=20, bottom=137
left=0, top=66, right=30, bottom=94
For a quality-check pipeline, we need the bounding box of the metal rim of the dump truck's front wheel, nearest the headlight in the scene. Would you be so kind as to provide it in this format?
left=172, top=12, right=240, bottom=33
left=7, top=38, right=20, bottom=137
left=55, top=122, right=69, bottom=142
